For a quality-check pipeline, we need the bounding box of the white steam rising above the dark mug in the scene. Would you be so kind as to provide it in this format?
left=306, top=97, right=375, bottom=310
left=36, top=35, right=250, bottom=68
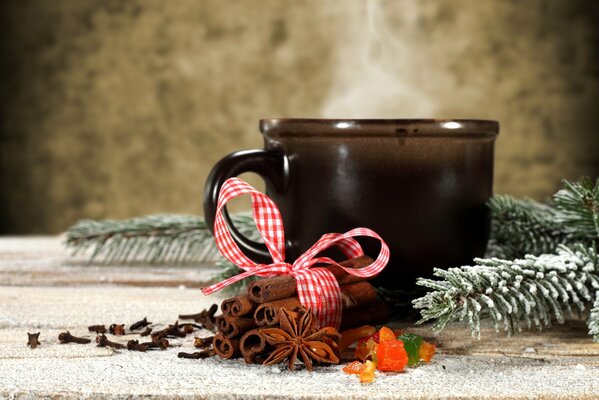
left=322, top=0, right=439, bottom=118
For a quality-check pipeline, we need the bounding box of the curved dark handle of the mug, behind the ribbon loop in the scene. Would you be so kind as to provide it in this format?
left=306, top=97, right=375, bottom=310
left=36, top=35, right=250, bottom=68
left=204, top=150, right=289, bottom=263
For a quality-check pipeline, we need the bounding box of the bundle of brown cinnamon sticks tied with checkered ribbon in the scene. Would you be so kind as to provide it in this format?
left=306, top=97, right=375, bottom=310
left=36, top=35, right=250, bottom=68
left=213, top=256, right=389, bottom=363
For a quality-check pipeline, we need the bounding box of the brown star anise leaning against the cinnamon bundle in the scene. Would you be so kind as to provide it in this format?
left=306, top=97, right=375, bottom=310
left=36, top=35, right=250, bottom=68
left=260, top=308, right=339, bottom=371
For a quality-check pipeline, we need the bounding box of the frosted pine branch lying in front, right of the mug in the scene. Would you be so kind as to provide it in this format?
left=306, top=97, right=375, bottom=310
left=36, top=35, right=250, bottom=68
left=413, top=244, right=599, bottom=339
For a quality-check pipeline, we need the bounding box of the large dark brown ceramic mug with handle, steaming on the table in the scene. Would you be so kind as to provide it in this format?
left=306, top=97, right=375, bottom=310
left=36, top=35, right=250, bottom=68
left=204, top=119, right=499, bottom=288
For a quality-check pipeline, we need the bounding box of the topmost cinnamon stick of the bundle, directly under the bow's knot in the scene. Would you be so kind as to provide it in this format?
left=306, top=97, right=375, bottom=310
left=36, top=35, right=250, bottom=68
left=248, top=256, right=374, bottom=304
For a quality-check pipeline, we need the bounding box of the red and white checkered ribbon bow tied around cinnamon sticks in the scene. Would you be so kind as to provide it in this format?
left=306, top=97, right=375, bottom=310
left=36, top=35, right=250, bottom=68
left=202, top=178, right=389, bottom=328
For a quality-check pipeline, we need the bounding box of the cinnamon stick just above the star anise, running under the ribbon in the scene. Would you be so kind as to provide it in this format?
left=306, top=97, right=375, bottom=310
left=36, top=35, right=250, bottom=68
left=254, top=282, right=376, bottom=326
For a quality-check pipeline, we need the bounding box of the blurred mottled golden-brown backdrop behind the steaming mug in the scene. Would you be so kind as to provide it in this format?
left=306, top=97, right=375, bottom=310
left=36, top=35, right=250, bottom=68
left=0, top=0, right=599, bottom=234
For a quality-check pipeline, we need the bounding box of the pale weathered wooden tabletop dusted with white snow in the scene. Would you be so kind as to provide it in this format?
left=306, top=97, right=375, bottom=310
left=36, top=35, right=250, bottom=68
left=0, top=237, right=599, bottom=399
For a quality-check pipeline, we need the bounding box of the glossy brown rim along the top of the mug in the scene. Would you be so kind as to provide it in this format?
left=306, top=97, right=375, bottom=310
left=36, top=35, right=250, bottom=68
left=260, top=118, right=499, bottom=138
